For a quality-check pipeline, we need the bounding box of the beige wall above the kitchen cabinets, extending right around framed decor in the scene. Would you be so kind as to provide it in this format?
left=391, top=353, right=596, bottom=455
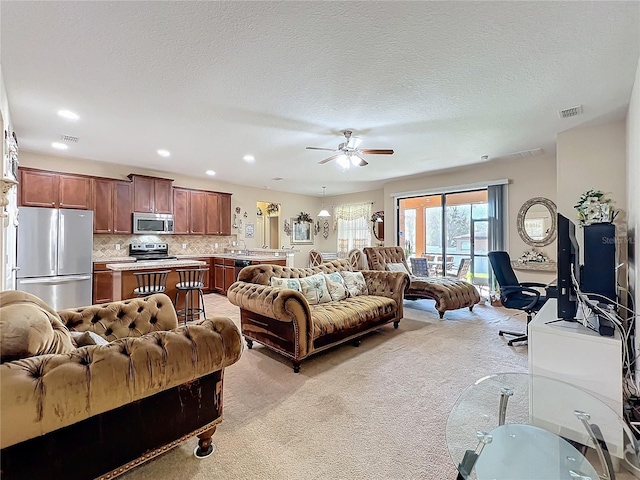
left=20, top=152, right=328, bottom=266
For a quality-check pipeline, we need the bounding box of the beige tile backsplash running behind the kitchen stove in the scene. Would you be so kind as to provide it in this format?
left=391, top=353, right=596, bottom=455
left=93, top=235, right=236, bottom=259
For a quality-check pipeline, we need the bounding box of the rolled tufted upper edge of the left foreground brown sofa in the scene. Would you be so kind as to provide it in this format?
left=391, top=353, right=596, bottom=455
left=0, top=317, right=243, bottom=448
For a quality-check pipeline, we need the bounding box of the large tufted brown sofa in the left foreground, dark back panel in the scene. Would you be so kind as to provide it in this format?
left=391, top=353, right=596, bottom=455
left=0, top=291, right=242, bottom=480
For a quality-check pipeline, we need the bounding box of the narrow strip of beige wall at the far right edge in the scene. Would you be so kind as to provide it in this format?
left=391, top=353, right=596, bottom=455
left=626, top=57, right=640, bottom=356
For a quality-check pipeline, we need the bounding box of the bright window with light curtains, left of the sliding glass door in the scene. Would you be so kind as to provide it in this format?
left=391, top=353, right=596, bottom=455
left=333, top=203, right=371, bottom=258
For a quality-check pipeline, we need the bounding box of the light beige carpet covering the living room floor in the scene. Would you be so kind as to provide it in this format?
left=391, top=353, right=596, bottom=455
left=122, top=294, right=527, bottom=480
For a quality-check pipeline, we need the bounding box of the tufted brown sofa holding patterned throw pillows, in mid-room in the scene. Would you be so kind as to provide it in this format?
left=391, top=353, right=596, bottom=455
left=227, top=260, right=409, bottom=373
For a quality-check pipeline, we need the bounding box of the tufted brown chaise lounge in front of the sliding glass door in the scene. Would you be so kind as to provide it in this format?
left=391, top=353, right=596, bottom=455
left=364, top=247, right=480, bottom=318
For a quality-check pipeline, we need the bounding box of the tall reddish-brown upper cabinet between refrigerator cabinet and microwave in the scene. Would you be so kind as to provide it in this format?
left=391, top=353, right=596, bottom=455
left=93, top=178, right=131, bottom=234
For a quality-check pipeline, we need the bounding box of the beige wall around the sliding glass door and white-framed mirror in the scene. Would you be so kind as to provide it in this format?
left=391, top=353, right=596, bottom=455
left=384, top=155, right=556, bottom=282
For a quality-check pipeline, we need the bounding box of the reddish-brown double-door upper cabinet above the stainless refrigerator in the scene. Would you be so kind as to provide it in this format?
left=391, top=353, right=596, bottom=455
left=19, top=168, right=92, bottom=210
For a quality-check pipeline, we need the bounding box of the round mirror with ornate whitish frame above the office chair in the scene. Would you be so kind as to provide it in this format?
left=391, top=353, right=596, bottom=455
left=518, top=197, right=556, bottom=247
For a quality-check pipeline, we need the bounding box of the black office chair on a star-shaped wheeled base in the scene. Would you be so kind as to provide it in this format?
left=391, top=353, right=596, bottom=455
left=489, top=252, right=554, bottom=346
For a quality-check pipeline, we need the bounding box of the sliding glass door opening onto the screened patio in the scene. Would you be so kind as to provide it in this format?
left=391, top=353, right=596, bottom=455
left=398, top=189, right=489, bottom=285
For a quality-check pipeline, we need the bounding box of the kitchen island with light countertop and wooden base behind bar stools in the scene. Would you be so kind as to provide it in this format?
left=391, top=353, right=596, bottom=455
left=106, top=260, right=209, bottom=309
